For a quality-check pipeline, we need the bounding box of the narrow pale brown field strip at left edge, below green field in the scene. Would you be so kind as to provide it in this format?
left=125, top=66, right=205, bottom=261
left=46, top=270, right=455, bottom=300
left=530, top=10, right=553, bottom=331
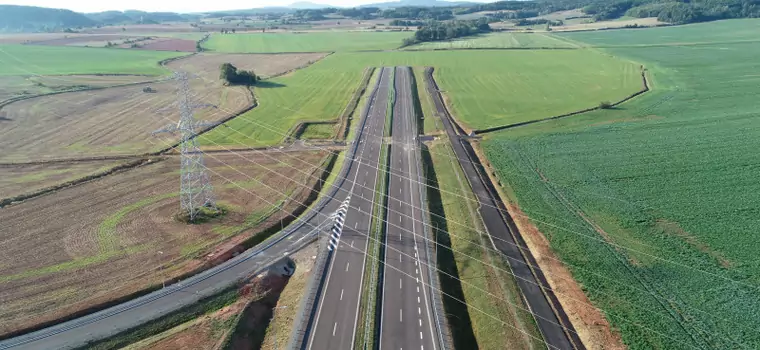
left=0, top=75, right=154, bottom=104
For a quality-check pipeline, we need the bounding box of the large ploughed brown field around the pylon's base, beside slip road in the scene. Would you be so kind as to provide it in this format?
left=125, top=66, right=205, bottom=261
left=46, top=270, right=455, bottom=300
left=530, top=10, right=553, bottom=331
left=0, top=151, right=325, bottom=334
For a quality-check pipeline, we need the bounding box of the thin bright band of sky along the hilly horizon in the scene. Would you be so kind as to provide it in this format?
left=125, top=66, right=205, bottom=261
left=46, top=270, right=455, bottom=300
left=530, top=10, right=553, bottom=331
left=0, top=0, right=495, bottom=13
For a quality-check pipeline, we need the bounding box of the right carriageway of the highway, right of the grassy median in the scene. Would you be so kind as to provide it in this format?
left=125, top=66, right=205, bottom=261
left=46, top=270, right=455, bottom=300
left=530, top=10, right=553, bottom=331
left=380, top=67, right=439, bottom=350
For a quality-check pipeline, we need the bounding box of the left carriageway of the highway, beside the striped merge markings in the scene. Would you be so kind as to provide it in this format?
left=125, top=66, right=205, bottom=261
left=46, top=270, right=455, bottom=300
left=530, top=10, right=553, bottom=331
left=307, top=68, right=391, bottom=350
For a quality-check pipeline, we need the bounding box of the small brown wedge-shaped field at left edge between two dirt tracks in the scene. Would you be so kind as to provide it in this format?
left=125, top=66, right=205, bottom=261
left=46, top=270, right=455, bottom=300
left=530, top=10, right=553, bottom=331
left=0, top=161, right=122, bottom=199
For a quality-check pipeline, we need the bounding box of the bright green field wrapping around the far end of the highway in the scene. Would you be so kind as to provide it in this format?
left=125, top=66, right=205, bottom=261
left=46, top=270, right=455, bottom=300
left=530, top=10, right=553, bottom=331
left=206, top=50, right=642, bottom=146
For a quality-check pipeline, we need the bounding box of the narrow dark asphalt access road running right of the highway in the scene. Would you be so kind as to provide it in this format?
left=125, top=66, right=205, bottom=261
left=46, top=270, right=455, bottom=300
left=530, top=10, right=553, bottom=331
left=425, top=71, right=584, bottom=349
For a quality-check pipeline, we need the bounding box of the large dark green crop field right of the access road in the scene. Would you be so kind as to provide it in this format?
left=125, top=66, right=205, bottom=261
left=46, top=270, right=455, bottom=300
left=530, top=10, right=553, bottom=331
left=483, top=20, right=760, bottom=349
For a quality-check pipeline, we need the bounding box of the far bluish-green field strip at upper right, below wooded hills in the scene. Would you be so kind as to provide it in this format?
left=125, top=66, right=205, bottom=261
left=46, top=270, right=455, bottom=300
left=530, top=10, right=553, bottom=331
left=556, top=19, right=760, bottom=46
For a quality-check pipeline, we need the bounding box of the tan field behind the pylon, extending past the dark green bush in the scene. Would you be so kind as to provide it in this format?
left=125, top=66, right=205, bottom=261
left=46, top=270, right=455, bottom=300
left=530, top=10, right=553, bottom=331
left=0, top=54, right=323, bottom=162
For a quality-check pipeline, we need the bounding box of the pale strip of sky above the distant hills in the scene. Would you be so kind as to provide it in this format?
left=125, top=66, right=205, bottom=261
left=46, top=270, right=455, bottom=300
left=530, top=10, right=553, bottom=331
left=0, top=0, right=486, bottom=12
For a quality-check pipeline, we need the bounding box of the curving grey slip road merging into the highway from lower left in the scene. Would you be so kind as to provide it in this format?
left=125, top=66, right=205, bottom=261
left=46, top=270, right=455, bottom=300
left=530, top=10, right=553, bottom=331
left=0, top=67, right=388, bottom=350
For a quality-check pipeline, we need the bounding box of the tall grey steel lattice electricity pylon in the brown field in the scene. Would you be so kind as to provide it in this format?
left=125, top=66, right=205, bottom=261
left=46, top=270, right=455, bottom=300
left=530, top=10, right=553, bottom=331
left=153, top=72, right=218, bottom=222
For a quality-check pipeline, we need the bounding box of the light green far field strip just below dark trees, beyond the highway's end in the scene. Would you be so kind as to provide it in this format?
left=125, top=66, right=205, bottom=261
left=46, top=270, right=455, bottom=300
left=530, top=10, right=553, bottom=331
left=406, top=32, right=578, bottom=50
